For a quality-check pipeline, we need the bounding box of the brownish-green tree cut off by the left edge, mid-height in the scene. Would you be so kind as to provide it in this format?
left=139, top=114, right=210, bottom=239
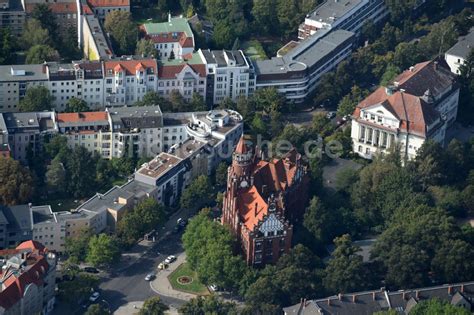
left=0, top=156, right=33, bottom=205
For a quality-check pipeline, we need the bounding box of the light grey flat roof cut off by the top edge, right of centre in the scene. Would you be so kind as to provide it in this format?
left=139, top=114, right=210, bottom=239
left=306, top=0, right=364, bottom=24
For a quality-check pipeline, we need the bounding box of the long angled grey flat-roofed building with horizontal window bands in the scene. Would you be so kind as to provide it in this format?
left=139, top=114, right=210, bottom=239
left=254, top=30, right=355, bottom=103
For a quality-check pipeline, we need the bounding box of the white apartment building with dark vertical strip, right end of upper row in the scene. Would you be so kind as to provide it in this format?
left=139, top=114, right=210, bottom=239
left=198, top=49, right=255, bottom=104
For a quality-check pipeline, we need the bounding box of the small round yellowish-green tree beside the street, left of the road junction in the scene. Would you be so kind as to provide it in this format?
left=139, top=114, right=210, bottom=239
left=86, top=234, right=120, bottom=267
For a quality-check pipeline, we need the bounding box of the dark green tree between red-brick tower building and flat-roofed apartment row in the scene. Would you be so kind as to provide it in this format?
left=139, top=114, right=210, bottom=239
left=180, top=175, right=213, bottom=209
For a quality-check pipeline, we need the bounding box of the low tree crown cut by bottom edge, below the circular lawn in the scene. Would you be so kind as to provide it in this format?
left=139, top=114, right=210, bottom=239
left=179, top=295, right=238, bottom=315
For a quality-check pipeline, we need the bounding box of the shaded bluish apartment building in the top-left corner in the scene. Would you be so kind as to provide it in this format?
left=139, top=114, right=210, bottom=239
left=0, top=0, right=26, bottom=37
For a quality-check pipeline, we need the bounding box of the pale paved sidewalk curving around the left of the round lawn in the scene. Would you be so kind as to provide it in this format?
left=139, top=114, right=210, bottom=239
left=150, top=252, right=197, bottom=301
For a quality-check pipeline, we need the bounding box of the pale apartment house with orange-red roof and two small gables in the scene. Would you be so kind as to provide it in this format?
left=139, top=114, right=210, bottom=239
left=103, top=57, right=158, bottom=106
